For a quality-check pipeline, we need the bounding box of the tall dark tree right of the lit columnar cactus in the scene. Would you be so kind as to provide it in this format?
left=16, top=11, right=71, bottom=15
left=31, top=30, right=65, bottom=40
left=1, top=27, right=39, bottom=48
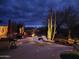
left=59, top=6, right=77, bottom=38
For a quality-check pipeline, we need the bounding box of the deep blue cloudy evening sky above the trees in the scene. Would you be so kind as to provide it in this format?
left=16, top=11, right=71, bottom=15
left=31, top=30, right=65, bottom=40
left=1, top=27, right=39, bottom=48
left=0, top=0, right=79, bottom=26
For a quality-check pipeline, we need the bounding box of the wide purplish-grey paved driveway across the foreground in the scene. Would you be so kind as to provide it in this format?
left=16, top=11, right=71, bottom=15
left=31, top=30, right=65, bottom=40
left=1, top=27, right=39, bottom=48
left=8, top=43, right=72, bottom=59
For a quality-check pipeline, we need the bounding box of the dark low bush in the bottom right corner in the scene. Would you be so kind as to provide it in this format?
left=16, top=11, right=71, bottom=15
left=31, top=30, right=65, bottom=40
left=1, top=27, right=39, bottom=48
left=60, top=52, right=79, bottom=59
